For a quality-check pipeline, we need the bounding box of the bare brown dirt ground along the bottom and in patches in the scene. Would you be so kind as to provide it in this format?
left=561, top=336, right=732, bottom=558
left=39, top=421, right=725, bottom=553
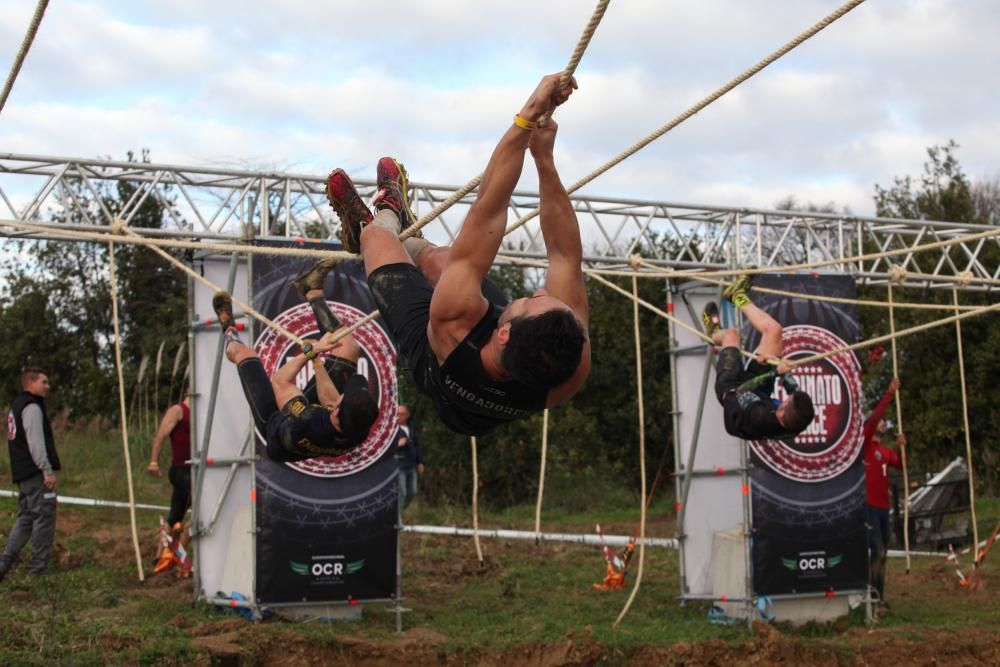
left=33, top=512, right=1000, bottom=667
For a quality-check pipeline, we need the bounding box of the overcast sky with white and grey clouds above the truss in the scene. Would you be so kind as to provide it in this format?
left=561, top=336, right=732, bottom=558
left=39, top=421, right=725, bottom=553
left=0, top=0, right=1000, bottom=215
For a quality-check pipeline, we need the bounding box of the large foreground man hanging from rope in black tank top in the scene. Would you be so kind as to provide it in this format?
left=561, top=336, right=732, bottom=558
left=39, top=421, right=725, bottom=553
left=300, top=74, right=590, bottom=435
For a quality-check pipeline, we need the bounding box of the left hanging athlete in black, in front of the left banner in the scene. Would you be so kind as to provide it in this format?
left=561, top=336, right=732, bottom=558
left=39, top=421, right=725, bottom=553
left=212, top=294, right=378, bottom=461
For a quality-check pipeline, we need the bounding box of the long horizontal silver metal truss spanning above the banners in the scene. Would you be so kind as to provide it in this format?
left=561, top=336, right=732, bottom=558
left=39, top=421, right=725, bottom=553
left=0, top=153, right=1000, bottom=291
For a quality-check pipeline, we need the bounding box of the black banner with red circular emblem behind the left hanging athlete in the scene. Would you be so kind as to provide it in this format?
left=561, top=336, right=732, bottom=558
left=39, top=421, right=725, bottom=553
left=251, top=244, right=399, bottom=604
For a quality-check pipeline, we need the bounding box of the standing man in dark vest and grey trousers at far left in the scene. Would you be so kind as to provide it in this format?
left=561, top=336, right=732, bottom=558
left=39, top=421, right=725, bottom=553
left=0, top=368, right=60, bottom=580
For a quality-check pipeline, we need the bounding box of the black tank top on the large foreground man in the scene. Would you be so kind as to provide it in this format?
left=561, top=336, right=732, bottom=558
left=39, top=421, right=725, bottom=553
left=431, top=304, right=549, bottom=435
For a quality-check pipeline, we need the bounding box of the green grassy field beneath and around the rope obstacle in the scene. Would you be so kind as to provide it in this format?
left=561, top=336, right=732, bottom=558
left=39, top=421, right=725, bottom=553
left=0, top=436, right=1000, bottom=665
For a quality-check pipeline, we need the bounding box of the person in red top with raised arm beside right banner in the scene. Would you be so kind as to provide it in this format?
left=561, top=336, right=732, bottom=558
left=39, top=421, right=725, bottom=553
left=863, top=378, right=906, bottom=611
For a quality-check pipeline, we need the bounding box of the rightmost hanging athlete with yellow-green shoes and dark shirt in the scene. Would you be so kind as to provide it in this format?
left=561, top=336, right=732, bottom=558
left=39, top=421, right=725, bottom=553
left=702, top=275, right=814, bottom=440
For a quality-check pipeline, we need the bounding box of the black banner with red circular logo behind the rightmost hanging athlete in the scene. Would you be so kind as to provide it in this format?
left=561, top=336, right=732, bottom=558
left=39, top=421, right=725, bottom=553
left=742, top=275, right=868, bottom=595
